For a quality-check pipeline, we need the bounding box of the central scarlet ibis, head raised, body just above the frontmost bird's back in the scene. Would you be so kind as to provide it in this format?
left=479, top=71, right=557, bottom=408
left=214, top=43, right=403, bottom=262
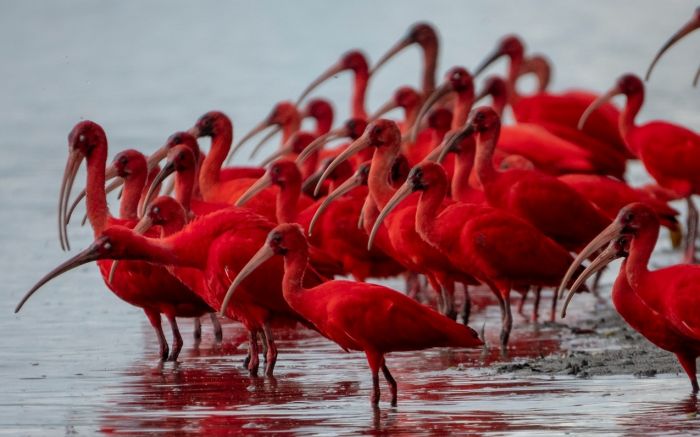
left=318, top=119, right=475, bottom=317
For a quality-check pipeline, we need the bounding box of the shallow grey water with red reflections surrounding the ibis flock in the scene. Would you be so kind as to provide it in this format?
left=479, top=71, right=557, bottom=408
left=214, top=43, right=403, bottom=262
left=0, top=0, right=700, bottom=435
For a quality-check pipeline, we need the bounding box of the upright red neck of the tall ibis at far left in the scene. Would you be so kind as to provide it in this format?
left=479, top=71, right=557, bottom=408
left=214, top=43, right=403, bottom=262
left=85, top=142, right=110, bottom=235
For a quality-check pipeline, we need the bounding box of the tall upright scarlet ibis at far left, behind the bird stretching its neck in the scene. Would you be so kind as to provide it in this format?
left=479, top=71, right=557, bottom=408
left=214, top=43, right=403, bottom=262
left=58, top=121, right=212, bottom=360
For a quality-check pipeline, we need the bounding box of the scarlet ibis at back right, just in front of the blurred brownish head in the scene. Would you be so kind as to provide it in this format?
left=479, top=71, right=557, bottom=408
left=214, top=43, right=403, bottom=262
left=474, top=35, right=629, bottom=157
